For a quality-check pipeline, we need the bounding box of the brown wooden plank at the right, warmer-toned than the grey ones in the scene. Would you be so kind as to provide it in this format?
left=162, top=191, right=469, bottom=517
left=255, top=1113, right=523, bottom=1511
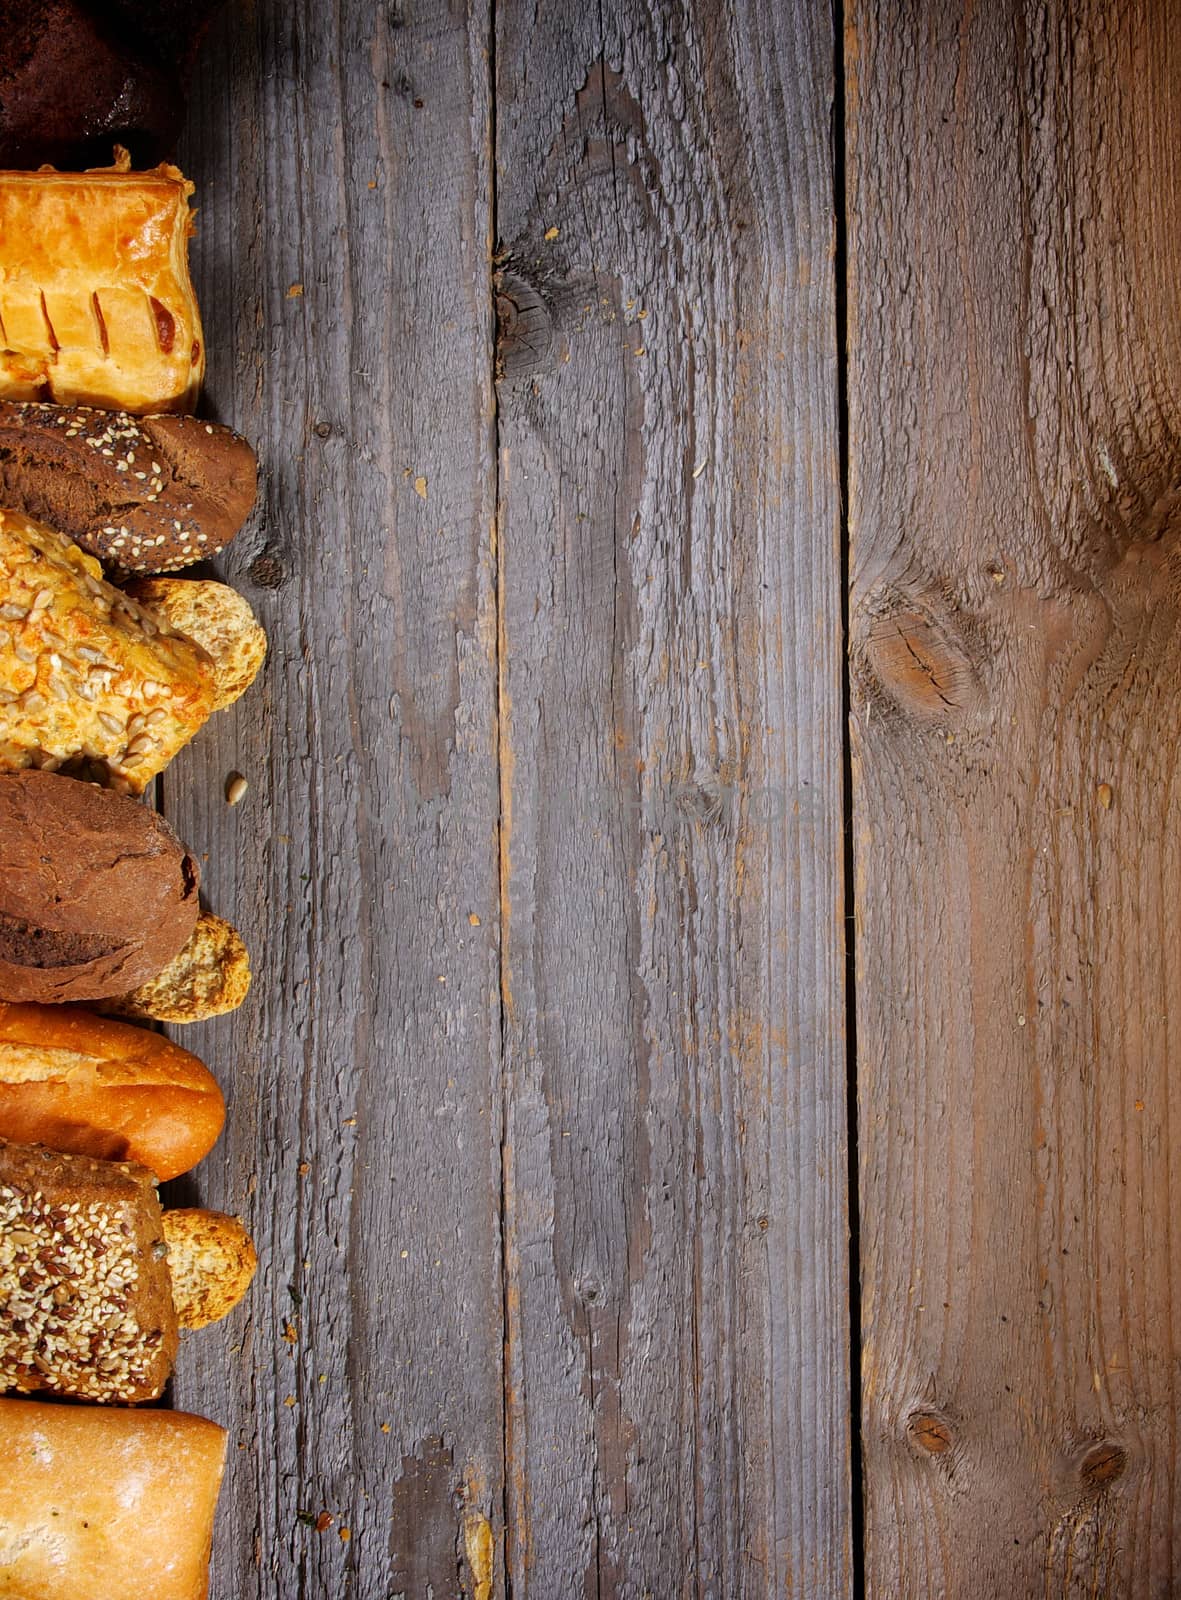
left=845, top=0, right=1181, bottom=1597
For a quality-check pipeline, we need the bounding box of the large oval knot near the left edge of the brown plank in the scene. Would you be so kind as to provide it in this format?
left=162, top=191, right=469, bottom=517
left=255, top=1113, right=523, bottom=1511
left=859, top=590, right=983, bottom=722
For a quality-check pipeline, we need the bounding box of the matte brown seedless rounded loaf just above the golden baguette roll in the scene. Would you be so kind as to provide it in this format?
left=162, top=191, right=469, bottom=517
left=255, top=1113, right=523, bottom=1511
left=0, top=771, right=200, bottom=1002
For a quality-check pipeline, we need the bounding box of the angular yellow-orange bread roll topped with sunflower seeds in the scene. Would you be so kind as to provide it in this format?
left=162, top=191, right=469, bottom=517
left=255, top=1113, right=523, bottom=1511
left=0, top=510, right=216, bottom=794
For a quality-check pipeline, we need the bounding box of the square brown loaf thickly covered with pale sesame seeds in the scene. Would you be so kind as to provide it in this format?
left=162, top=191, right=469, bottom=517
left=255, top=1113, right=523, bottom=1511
left=0, top=1139, right=178, bottom=1401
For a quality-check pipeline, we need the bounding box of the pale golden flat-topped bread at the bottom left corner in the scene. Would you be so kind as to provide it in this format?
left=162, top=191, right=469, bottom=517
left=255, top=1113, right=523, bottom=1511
left=0, top=1400, right=226, bottom=1600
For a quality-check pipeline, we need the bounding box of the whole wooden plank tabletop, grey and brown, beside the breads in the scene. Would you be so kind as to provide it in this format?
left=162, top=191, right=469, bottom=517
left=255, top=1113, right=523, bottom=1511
left=162, top=0, right=1181, bottom=1600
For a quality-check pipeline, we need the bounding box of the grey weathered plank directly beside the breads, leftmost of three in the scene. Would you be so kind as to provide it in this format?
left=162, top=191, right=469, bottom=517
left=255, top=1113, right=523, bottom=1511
left=165, top=0, right=502, bottom=1600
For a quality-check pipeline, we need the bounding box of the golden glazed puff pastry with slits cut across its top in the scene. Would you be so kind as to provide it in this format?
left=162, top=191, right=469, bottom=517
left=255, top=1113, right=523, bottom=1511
left=0, top=166, right=205, bottom=413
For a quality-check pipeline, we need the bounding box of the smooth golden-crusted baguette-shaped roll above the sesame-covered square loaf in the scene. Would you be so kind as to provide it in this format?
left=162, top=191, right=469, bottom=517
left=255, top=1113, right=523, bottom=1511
left=0, top=1005, right=226, bottom=1182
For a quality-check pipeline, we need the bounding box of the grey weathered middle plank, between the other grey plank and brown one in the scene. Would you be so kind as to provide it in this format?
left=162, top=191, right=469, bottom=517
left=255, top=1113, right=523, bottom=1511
left=496, top=0, right=850, bottom=1600
